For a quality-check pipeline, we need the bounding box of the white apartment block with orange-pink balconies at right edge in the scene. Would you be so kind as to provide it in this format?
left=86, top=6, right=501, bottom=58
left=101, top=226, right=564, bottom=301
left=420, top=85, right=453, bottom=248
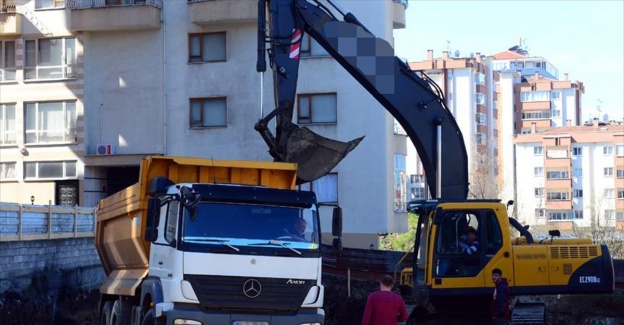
left=514, top=119, right=624, bottom=230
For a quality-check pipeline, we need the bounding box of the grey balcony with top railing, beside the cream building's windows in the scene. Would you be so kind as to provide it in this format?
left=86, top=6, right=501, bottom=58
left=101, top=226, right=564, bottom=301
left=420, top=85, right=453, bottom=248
left=67, top=0, right=163, bottom=32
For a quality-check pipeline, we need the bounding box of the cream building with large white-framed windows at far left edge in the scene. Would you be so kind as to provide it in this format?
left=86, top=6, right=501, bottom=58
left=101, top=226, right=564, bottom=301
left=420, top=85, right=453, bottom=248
left=0, top=0, right=85, bottom=205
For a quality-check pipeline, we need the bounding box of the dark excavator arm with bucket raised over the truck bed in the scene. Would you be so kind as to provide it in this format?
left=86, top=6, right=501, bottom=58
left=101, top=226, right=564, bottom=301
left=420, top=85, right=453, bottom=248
left=256, top=0, right=468, bottom=199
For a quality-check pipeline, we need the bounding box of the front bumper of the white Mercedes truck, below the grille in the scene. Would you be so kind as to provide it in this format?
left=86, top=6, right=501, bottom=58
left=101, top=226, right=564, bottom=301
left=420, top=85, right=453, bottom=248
left=163, top=305, right=325, bottom=325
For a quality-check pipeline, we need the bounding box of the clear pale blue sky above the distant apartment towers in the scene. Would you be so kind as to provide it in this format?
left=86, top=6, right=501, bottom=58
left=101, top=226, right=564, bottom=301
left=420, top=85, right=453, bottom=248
left=394, top=0, right=624, bottom=121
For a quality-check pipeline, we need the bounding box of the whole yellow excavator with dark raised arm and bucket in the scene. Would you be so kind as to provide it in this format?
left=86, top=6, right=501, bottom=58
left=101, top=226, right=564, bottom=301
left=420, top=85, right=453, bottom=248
left=255, top=0, right=614, bottom=324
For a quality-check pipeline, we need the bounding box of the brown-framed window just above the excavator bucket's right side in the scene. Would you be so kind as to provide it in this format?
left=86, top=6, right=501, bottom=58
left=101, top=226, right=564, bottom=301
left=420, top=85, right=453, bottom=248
left=297, top=93, right=337, bottom=124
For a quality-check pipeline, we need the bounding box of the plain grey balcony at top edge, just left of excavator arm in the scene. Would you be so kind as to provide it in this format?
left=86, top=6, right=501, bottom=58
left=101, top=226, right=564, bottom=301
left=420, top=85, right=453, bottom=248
left=188, top=0, right=258, bottom=26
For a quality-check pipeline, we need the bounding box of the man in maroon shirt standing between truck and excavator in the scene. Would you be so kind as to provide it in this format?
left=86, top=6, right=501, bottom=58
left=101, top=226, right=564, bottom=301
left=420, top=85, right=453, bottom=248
left=362, top=275, right=408, bottom=325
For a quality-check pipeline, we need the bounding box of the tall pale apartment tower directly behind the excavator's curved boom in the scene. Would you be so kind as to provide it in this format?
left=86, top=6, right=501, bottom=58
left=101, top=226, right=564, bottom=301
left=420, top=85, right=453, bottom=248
left=408, top=50, right=499, bottom=199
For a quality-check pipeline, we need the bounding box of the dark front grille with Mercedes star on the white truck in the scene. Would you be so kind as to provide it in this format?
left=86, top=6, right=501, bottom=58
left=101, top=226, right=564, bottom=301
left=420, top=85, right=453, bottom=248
left=184, top=274, right=316, bottom=314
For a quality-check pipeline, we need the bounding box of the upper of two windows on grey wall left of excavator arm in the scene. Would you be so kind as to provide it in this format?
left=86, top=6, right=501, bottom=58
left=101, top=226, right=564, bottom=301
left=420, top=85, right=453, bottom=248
left=189, top=32, right=227, bottom=62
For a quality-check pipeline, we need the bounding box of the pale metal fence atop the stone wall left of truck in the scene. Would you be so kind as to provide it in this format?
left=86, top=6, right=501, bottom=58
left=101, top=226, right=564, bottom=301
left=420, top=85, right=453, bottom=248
left=0, top=203, right=95, bottom=241
